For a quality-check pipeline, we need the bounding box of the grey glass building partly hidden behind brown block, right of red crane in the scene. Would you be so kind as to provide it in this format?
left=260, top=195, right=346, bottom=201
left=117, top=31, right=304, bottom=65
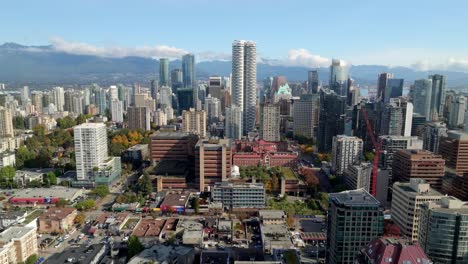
left=379, top=136, right=423, bottom=169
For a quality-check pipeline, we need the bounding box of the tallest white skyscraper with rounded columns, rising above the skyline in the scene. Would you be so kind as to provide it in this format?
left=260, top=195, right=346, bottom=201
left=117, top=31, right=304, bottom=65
left=231, top=40, right=257, bottom=134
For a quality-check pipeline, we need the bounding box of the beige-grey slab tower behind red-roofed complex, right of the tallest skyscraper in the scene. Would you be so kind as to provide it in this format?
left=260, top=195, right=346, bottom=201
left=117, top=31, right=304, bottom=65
left=260, top=104, right=281, bottom=141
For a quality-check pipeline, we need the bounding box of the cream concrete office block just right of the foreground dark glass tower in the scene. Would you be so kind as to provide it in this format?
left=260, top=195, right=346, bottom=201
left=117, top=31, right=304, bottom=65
left=391, top=179, right=443, bottom=241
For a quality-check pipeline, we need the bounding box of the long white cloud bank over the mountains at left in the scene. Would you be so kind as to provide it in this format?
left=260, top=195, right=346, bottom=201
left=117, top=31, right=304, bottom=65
left=51, top=37, right=188, bottom=58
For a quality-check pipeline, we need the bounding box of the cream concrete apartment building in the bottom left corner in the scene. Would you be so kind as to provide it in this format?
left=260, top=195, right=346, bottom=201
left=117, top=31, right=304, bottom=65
left=0, top=226, right=39, bottom=263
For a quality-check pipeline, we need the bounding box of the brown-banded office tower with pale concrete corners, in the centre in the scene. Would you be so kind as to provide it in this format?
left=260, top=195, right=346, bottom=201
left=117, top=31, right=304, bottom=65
left=195, top=139, right=232, bottom=192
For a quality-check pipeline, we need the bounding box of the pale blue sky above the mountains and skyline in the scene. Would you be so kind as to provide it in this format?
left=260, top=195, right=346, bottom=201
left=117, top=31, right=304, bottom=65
left=0, top=0, right=468, bottom=72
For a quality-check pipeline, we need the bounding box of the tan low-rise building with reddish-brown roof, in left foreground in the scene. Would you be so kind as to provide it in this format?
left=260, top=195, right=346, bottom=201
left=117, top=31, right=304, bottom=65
left=38, top=207, right=78, bottom=233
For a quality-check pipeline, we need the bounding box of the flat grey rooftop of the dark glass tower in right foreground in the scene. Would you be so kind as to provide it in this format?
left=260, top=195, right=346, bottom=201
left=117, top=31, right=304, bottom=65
left=330, top=189, right=380, bottom=206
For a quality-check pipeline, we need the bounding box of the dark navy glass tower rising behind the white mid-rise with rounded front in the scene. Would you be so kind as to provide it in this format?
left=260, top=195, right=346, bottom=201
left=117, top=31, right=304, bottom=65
left=317, top=90, right=346, bottom=152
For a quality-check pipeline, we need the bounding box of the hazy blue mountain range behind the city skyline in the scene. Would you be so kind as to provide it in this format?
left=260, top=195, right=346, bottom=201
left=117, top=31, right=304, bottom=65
left=0, top=43, right=468, bottom=87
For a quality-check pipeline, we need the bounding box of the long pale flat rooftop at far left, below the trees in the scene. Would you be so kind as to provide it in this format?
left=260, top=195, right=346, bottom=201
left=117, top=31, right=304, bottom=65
left=13, top=186, right=83, bottom=200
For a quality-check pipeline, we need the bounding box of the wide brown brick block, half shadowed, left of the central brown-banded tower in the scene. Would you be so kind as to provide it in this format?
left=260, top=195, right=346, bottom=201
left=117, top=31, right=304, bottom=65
left=150, top=132, right=198, bottom=163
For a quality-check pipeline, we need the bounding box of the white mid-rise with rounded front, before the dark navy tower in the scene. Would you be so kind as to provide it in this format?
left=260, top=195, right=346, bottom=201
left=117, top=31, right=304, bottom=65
left=332, top=135, right=363, bottom=175
